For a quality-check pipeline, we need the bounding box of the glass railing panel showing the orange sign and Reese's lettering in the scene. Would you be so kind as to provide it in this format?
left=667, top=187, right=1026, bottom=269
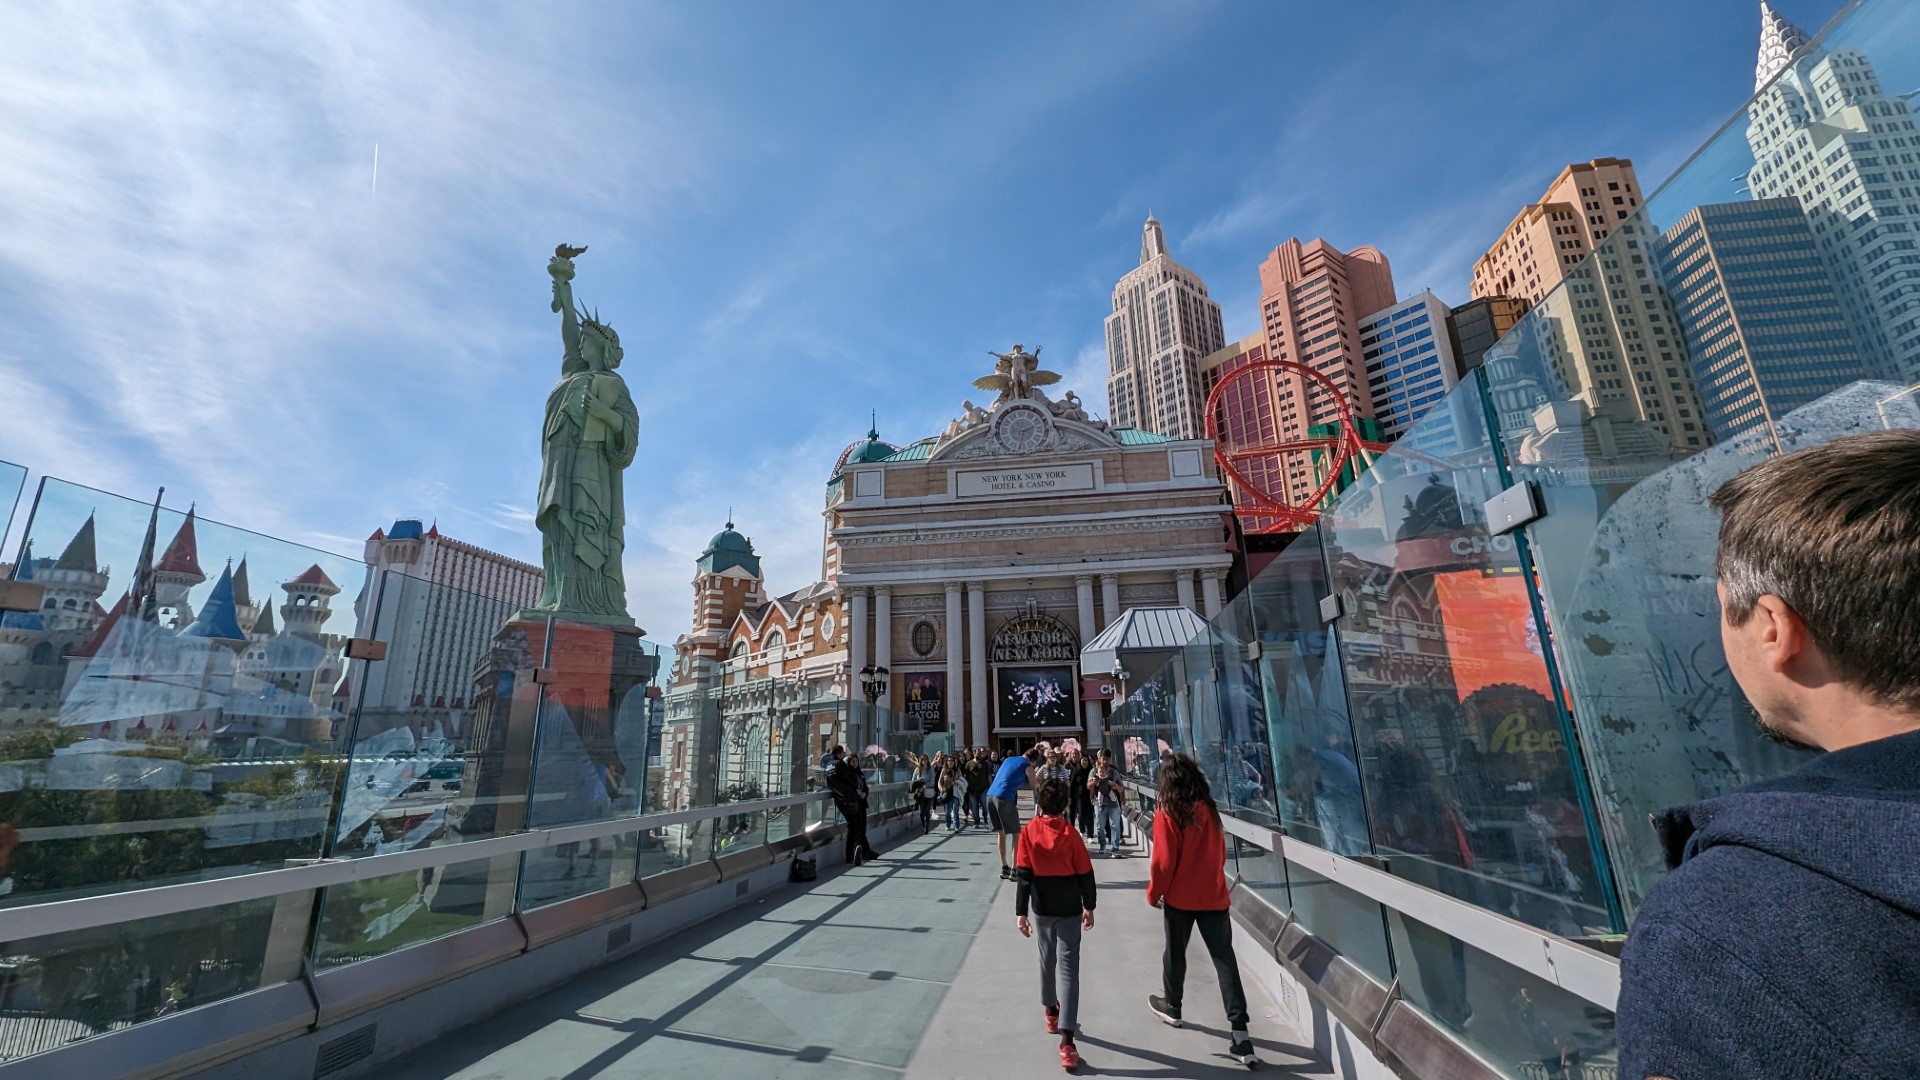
left=1321, top=380, right=1613, bottom=936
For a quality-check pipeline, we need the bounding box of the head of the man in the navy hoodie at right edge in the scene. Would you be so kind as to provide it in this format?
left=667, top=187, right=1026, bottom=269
left=1713, top=430, right=1920, bottom=749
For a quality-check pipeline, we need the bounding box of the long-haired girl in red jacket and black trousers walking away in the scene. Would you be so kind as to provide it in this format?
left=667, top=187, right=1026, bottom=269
left=1146, top=753, right=1258, bottom=1068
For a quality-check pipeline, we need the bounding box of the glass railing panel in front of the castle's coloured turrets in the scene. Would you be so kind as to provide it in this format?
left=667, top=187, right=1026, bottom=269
left=0, top=479, right=361, bottom=903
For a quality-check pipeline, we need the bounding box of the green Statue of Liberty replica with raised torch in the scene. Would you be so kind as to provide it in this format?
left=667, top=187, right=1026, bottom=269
left=530, top=244, right=639, bottom=626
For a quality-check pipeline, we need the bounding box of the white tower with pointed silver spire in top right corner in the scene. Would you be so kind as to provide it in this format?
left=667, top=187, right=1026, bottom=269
left=1747, top=4, right=1920, bottom=382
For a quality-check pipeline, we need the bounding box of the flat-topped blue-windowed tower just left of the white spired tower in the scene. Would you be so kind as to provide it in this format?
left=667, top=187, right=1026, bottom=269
left=1661, top=198, right=1872, bottom=440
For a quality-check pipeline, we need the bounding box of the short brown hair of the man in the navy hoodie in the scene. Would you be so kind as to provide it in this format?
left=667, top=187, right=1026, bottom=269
left=1713, top=430, right=1920, bottom=709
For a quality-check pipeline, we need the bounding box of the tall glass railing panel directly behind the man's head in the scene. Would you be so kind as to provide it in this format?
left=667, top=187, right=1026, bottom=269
left=1459, top=0, right=1920, bottom=917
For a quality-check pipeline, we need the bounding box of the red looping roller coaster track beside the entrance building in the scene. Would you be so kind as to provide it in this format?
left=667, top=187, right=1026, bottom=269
left=1206, top=359, right=1386, bottom=532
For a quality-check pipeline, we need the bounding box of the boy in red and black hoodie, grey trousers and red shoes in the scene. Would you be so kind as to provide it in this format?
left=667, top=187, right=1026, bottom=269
left=1014, top=780, right=1098, bottom=1070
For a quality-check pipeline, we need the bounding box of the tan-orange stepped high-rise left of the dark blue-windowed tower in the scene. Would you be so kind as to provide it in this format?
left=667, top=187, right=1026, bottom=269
left=1473, top=158, right=1713, bottom=450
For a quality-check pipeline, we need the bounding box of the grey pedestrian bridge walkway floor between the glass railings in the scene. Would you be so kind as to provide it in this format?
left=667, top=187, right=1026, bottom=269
left=364, top=828, right=1332, bottom=1080
